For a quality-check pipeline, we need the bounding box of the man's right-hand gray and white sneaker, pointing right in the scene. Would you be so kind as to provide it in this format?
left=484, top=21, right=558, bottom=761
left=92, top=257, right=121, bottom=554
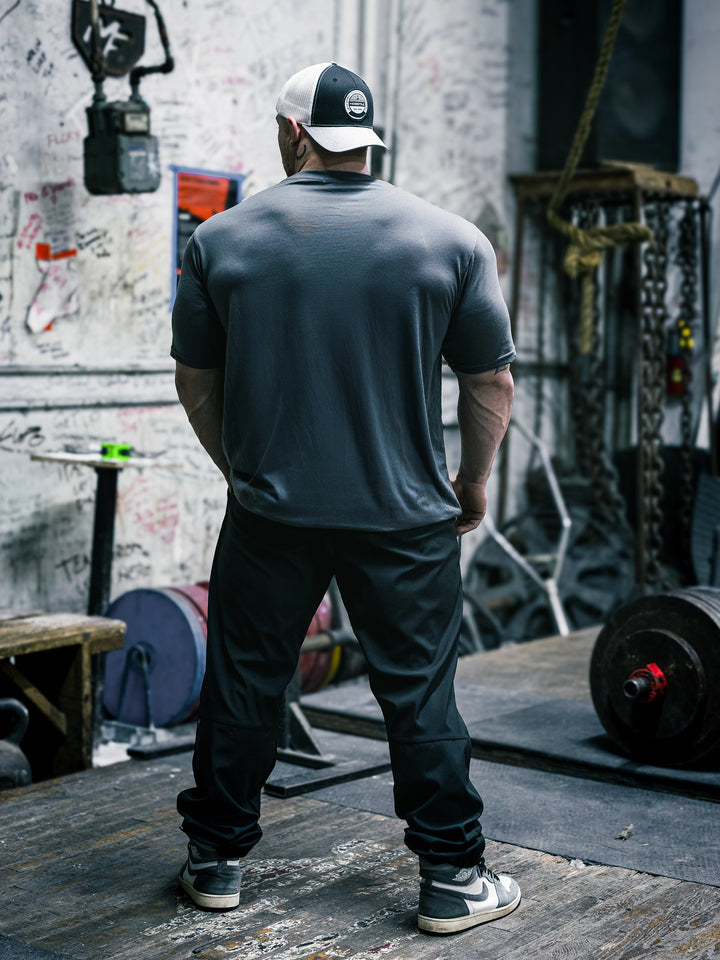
left=418, top=858, right=520, bottom=933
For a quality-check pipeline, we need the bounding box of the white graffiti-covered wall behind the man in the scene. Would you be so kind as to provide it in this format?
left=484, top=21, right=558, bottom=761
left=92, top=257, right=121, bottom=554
left=0, top=0, right=524, bottom=610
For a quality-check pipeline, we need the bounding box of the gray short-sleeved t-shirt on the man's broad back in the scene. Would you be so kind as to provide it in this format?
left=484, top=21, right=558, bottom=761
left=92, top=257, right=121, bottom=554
left=171, top=170, right=515, bottom=530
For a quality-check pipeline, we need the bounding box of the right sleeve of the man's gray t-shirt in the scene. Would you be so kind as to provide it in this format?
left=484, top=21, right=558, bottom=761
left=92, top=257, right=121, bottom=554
left=442, top=230, right=515, bottom=373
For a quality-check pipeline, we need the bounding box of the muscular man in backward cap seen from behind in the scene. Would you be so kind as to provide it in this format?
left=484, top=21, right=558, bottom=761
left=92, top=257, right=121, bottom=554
left=172, top=63, right=520, bottom=933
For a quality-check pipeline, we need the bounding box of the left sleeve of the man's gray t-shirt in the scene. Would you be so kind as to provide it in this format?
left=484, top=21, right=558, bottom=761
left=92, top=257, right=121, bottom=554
left=170, top=234, right=225, bottom=370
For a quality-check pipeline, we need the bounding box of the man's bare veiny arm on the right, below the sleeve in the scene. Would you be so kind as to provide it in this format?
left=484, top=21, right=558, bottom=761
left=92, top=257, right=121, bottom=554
left=452, top=364, right=514, bottom=536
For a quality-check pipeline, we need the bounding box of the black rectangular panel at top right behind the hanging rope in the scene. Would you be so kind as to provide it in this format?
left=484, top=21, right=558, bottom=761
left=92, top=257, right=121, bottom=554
left=538, top=0, right=682, bottom=172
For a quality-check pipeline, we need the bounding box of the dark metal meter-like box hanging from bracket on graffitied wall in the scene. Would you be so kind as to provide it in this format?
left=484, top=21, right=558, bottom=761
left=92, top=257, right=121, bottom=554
left=72, top=0, right=174, bottom=194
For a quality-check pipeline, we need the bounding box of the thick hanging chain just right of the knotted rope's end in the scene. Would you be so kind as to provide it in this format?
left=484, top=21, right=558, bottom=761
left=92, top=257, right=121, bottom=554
left=639, top=198, right=671, bottom=587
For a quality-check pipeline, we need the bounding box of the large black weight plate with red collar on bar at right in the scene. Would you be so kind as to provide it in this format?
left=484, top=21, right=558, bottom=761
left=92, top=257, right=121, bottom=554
left=590, top=590, right=720, bottom=766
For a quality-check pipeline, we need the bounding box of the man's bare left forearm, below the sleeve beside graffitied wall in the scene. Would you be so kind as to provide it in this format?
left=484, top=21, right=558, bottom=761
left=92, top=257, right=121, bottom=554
left=175, top=363, right=230, bottom=483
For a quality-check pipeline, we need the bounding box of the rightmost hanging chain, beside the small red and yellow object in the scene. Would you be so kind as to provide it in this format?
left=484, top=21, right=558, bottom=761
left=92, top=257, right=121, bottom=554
left=677, top=200, right=698, bottom=565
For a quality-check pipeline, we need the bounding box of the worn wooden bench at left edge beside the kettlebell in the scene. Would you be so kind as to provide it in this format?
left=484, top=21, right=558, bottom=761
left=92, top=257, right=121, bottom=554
left=0, top=613, right=125, bottom=780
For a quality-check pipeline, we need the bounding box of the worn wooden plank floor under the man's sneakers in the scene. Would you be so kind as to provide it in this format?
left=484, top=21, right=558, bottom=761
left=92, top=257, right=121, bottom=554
left=0, top=754, right=720, bottom=960
